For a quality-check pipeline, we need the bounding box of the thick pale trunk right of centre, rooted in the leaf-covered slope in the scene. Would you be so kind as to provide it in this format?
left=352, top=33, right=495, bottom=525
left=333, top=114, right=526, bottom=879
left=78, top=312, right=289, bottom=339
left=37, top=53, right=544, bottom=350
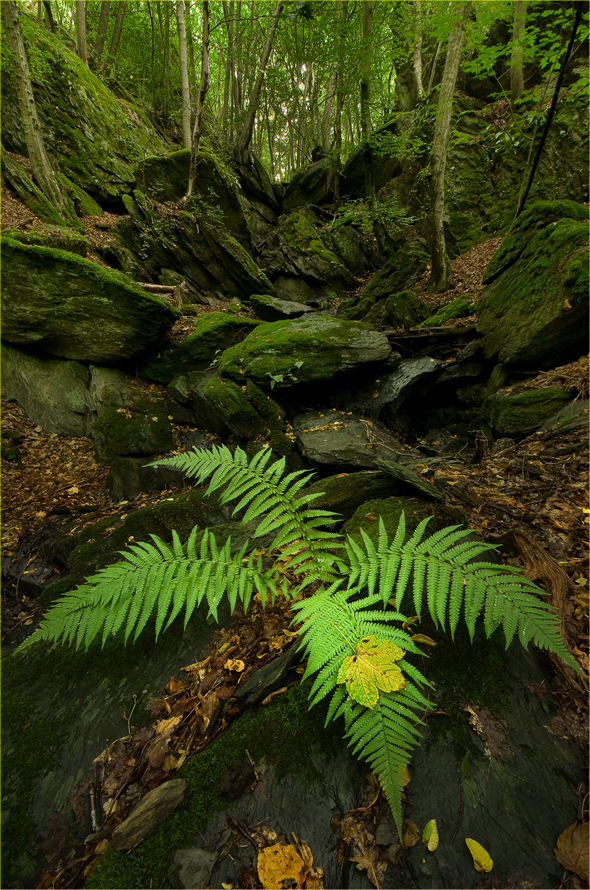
left=428, top=0, right=471, bottom=293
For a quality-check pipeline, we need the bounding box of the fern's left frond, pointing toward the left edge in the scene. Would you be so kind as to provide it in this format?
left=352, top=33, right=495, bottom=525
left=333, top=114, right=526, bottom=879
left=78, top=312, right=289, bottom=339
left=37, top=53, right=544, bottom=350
left=21, top=530, right=276, bottom=648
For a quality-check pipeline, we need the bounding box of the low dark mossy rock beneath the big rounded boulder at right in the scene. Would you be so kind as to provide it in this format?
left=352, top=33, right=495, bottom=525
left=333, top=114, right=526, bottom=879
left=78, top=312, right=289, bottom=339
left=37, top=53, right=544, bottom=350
left=482, top=386, right=572, bottom=436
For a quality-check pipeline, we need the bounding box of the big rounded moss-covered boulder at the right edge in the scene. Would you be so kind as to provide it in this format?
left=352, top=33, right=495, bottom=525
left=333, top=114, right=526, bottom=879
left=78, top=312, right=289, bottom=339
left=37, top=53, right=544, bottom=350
left=477, top=201, right=589, bottom=370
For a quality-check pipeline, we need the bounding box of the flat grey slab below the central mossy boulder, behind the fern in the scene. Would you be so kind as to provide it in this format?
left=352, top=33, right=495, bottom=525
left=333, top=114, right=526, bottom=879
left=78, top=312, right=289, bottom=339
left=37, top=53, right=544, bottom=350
left=293, top=409, right=404, bottom=468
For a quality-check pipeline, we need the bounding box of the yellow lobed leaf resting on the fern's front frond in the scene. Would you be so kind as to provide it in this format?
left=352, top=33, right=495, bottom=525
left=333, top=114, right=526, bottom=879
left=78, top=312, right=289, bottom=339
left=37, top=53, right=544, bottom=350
left=336, top=634, right=406, bottom=708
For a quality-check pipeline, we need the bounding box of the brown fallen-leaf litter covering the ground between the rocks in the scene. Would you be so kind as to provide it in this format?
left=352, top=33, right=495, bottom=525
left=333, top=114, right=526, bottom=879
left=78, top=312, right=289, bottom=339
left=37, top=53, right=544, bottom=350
left=1, top=177, right=590, bottom=887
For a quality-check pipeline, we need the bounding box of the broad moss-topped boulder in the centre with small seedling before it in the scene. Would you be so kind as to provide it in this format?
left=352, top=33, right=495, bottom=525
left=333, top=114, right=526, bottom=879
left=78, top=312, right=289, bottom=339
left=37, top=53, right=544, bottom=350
left=219, top=313, right=391, bottom=387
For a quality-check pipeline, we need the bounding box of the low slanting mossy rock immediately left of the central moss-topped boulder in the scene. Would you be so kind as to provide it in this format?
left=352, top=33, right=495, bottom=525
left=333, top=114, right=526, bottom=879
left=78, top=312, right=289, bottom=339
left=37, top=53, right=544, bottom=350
left=140, top=312, right=260, bottom=384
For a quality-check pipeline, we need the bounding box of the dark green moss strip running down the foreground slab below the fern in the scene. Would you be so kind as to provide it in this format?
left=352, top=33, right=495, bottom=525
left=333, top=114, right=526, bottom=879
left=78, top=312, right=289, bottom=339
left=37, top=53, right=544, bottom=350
left=85, top=683, right=366, bottom=888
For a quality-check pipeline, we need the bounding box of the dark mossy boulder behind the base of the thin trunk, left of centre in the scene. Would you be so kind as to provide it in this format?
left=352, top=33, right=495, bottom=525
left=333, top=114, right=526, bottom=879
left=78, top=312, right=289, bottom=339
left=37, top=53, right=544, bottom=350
left=135, top=146, right=251, bottom=251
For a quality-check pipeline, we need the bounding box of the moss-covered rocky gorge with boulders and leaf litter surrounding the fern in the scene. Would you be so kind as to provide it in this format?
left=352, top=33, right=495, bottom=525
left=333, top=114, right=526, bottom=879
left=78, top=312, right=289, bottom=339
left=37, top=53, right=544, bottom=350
left=1, top=12, right=589, bottom=887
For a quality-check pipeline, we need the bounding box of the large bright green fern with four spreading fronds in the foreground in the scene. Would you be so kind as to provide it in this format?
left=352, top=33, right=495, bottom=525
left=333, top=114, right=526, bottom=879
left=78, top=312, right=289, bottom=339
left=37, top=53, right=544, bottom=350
left=20, top=447, right=579, bottom=834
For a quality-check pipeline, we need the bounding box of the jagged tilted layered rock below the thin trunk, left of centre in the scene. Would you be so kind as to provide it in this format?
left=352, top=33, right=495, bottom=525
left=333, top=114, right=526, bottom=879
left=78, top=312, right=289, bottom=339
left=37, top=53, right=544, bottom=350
left=117, top=189, right=275, bottom=300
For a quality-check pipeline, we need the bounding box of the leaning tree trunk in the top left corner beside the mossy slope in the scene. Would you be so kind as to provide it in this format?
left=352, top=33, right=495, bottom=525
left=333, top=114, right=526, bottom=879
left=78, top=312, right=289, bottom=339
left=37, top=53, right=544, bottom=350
left=0, top=0, right=66, bottom=211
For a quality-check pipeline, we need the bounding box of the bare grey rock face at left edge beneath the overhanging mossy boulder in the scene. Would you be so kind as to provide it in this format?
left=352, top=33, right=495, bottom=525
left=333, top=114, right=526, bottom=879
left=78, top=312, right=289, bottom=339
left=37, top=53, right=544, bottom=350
left=2, top=343, right=90, bottom=436
